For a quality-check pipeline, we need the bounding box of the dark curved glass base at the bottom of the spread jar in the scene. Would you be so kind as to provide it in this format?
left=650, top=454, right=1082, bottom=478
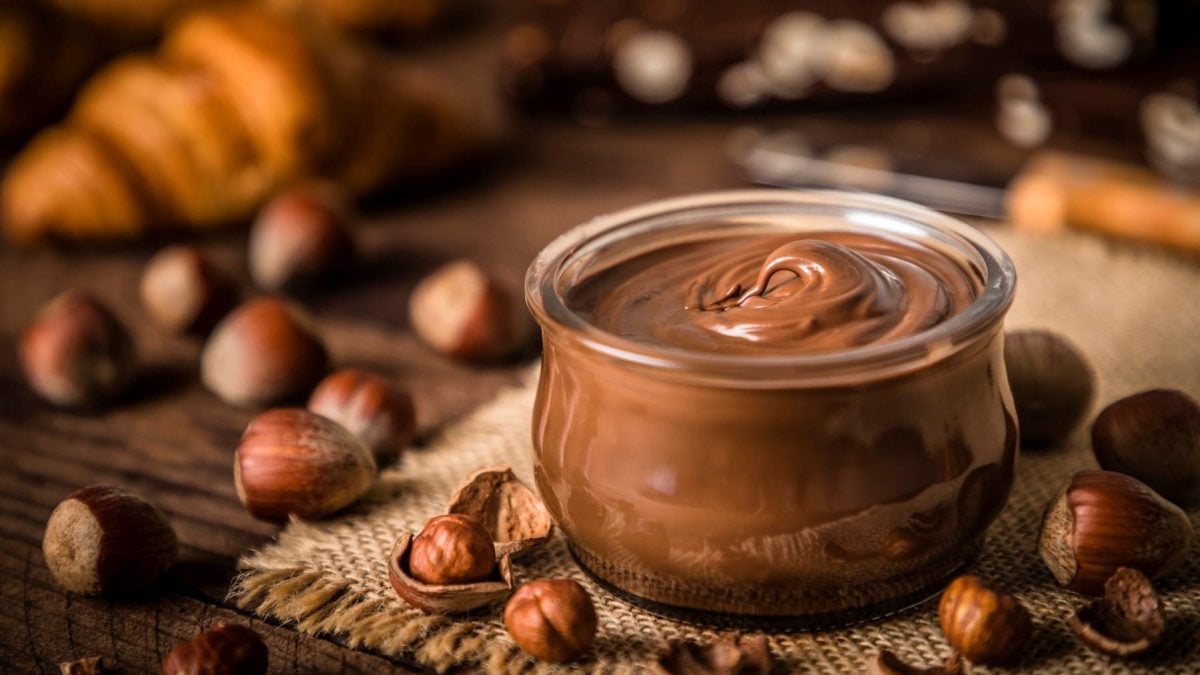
left=568, top=537, right=983, bottom=631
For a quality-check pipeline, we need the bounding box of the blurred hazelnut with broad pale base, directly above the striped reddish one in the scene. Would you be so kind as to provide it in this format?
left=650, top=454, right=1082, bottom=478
left=200, top=298, right=328, bottom=407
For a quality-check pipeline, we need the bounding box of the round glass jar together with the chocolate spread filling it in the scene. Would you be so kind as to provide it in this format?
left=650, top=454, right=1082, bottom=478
left=527, top=192, right=1018, bottom=616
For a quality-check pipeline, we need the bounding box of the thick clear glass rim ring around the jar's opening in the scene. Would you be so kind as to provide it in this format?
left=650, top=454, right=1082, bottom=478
left=524, top=189, right=1016, bottom=387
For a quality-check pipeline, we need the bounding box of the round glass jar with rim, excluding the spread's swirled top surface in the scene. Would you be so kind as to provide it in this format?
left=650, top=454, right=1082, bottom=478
left=526, top=190, right=1018, bottom=617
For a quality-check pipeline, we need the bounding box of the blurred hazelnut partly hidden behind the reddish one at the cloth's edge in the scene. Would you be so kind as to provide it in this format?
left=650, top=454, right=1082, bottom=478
left=308, top=369, right=416, bottom=466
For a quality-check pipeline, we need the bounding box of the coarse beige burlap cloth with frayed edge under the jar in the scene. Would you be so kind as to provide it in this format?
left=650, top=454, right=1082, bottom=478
left=232, top=228, right=1200, bottom=673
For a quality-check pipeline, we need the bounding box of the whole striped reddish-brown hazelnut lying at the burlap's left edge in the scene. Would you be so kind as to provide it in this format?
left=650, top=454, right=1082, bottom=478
left=233, top=408, right=376, bottom=521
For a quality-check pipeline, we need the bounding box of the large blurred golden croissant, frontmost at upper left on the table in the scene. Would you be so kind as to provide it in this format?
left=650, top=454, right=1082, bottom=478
left=0, top=6, right=491, bottom=241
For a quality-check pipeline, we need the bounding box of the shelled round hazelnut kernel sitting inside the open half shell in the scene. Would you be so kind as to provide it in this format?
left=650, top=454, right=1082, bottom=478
left=408, top=513, right=496, bottom=585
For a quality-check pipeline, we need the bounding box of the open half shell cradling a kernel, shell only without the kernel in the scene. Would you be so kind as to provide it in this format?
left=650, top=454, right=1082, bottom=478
left=388, top=532, right=512, bottom=614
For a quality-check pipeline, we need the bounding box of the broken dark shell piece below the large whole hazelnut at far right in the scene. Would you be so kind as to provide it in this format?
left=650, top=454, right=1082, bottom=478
left=1069, top=567, right=1166, bottom=656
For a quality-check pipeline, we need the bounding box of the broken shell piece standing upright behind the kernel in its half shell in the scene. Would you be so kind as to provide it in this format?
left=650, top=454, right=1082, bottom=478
left=446, top=466, right=554, bottom=557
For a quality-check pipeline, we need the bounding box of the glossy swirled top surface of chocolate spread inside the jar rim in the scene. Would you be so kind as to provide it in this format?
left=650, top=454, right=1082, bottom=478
left=569, top=232, right=980, bottom=353
